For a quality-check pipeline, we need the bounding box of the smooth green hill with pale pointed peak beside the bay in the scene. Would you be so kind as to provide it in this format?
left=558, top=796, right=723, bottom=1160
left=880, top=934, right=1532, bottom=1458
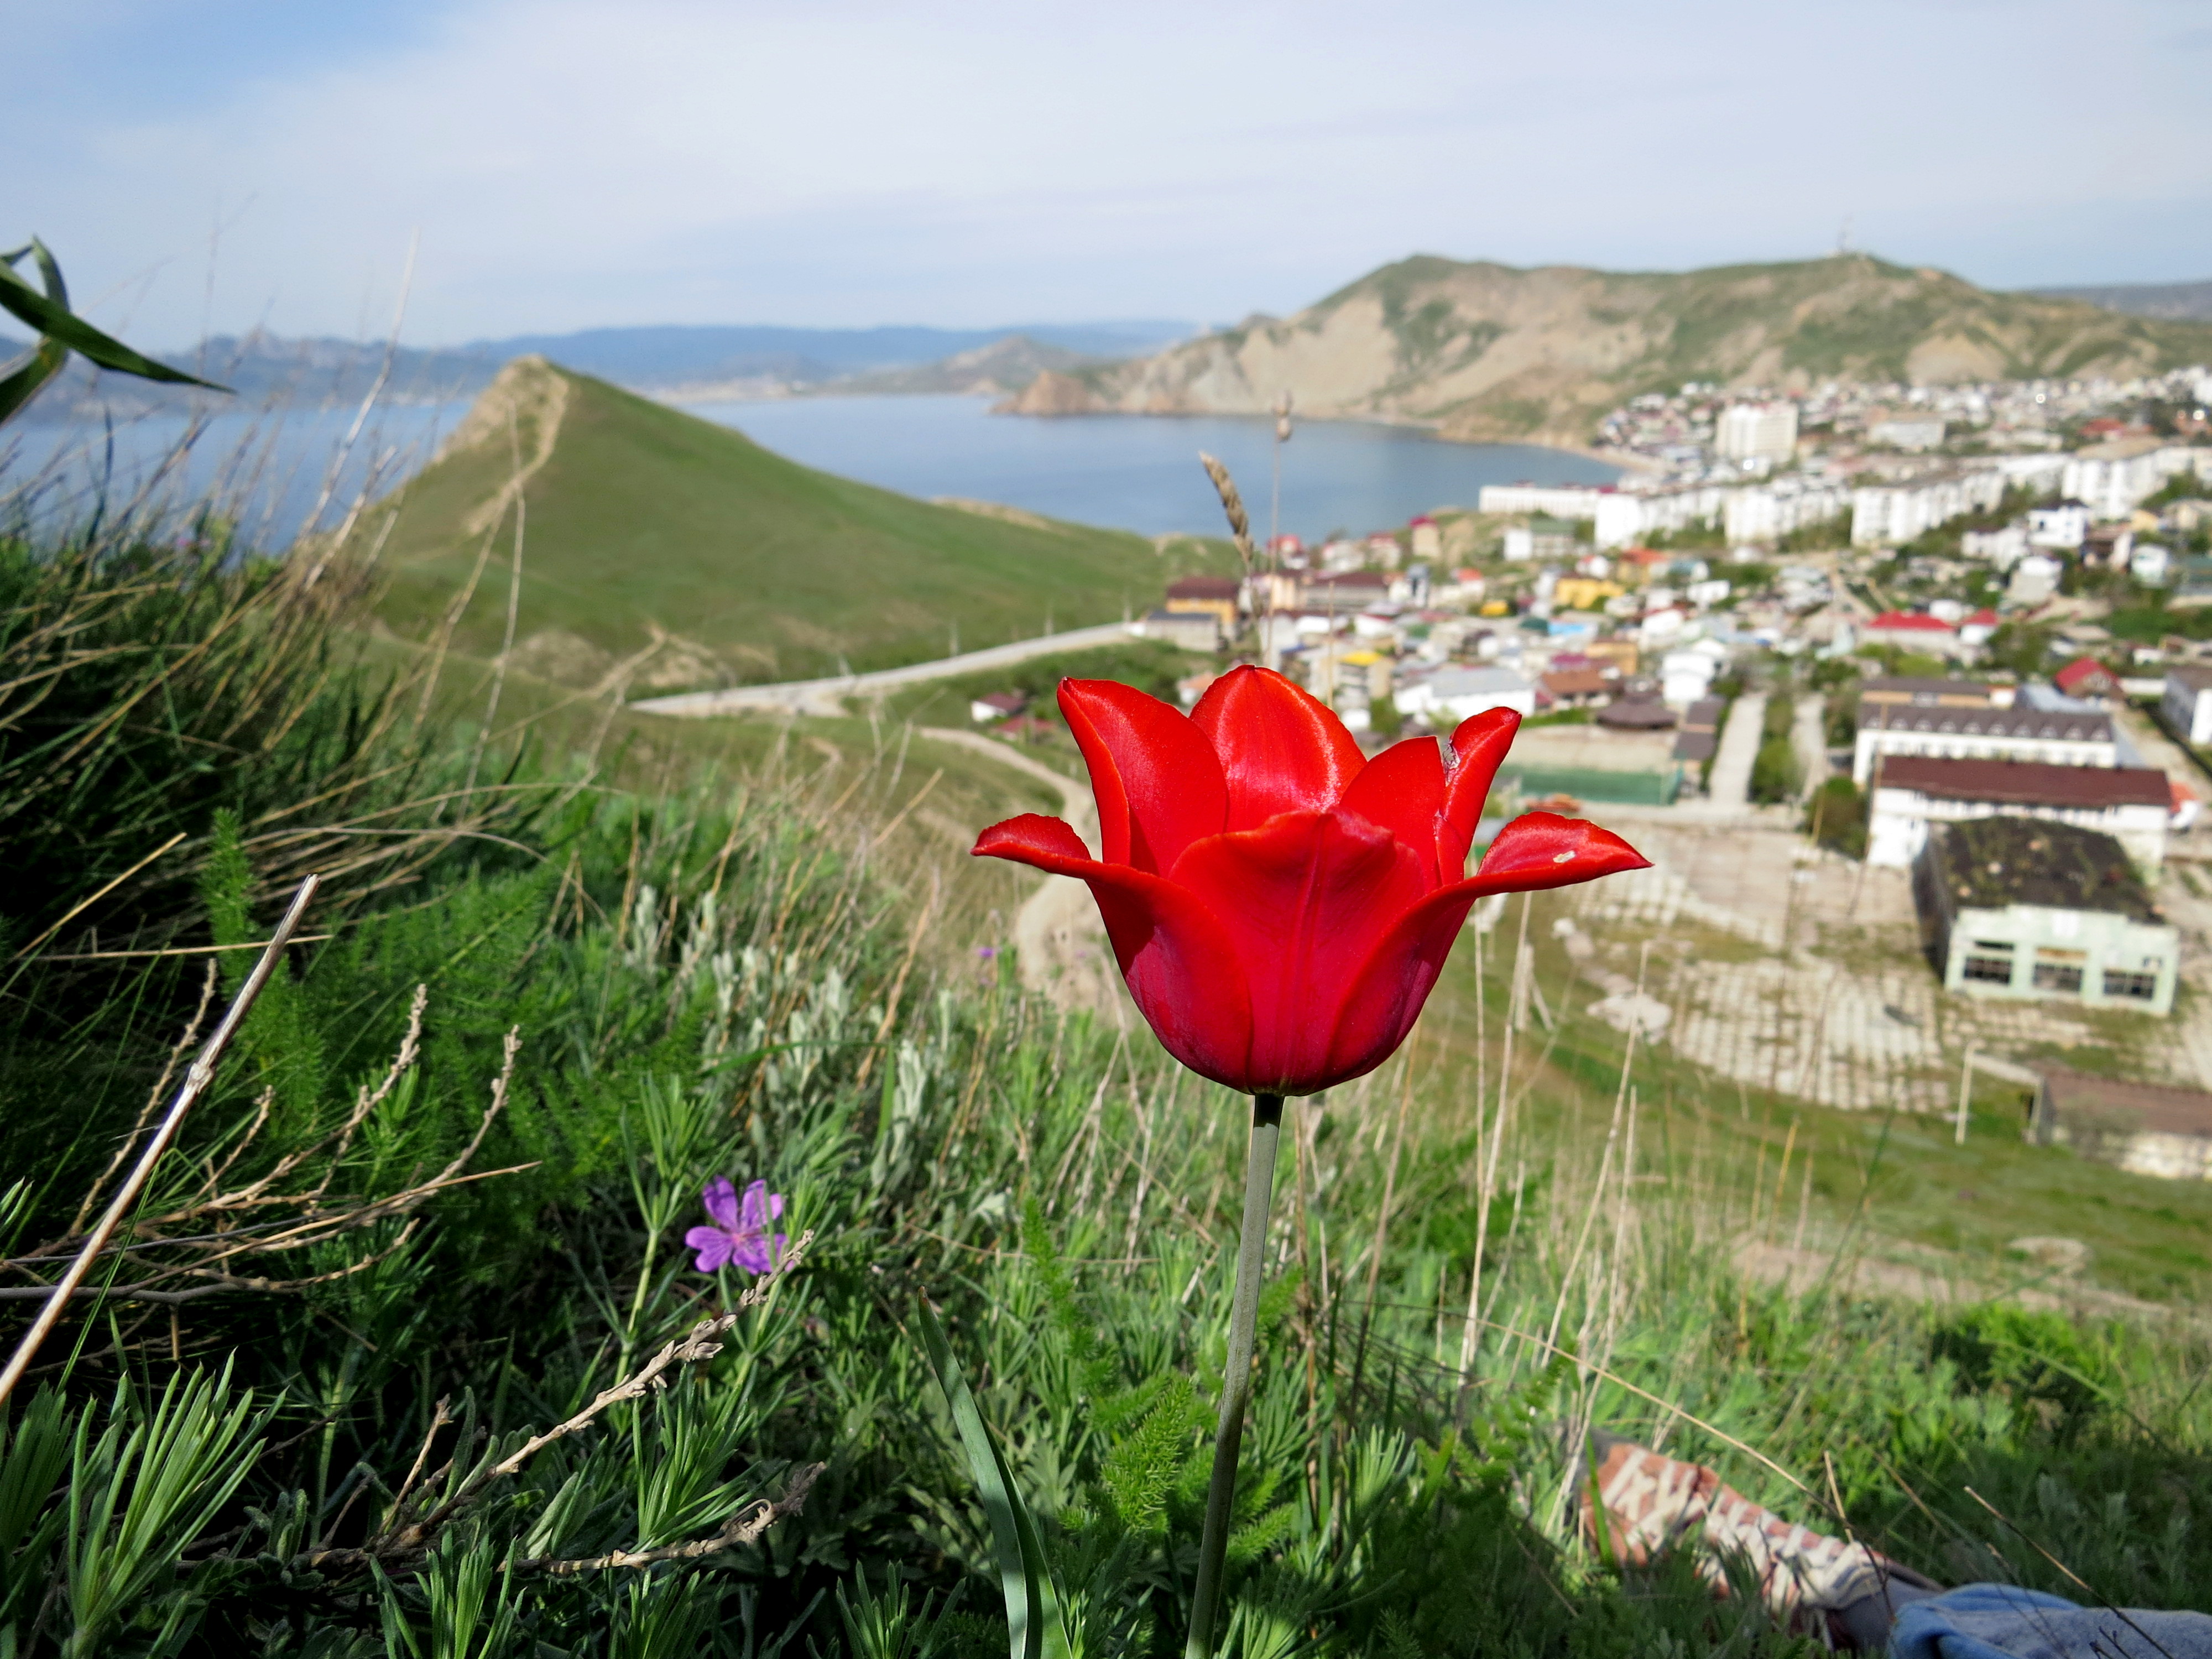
left=352, top=358, right=1223, bottom=690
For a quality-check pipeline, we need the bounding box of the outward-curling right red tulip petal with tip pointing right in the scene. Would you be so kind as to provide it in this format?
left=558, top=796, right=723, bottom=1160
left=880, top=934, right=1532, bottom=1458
left=1325, top=814, right=1650, bottom=1082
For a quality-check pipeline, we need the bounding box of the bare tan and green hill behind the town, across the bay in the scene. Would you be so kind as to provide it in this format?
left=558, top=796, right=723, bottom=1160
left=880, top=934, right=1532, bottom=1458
left=1004, top=254, right=2212, bottom=445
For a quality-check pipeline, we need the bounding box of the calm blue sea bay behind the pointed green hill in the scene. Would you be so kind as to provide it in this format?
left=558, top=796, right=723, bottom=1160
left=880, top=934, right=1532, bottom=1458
left=0, top=396, right=1619, bottom=549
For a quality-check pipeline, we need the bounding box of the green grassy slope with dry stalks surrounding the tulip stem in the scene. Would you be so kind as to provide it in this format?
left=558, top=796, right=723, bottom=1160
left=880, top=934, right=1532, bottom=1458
left=0, top=522, right=2212, bottom=1659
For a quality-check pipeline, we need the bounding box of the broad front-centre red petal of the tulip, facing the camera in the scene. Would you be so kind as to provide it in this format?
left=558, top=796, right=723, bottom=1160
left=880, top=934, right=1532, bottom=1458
left=1175, top=812, right=1429, bottom=1095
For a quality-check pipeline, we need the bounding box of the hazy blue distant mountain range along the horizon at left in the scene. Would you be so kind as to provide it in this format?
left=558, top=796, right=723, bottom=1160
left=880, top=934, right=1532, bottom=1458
left=0, top=319, right=1197, bottom=420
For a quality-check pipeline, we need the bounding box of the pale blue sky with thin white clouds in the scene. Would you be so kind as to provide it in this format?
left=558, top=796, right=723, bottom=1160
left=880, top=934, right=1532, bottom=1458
left=17, top=0, right=2212, bottom=349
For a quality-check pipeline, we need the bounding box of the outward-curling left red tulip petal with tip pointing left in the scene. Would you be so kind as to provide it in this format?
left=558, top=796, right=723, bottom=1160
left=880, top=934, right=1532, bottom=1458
left=975, top=812, right=1254, bottom=1091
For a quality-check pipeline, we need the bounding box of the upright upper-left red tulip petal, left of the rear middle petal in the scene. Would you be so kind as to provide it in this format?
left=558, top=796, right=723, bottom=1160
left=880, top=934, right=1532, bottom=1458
left=1060, top=679, right=1228, bottom=876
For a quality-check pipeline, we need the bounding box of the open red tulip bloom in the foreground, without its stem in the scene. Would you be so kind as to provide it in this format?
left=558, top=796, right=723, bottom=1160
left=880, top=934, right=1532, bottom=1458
left=975, top=668, right=1648, bottom=1095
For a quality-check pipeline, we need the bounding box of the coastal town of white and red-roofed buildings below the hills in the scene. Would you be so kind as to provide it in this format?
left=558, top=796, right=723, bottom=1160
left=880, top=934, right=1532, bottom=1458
left=971, top=369, right=2212, bottom=1177
